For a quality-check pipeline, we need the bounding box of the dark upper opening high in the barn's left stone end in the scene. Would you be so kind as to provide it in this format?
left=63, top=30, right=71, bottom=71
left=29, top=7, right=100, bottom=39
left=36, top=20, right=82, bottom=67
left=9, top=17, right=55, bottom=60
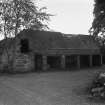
left=20, top=39, right=29, bottom=53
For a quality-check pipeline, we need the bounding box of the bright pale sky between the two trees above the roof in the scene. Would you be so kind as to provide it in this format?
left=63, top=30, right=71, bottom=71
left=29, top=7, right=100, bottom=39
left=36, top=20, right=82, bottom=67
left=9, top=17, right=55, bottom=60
left=38, top=0, right=94, bottom=35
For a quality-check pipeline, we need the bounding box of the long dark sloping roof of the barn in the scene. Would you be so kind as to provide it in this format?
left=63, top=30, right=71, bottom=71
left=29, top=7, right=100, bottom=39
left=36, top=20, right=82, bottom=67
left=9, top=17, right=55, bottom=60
left=18, top=30, right=100, bottom=54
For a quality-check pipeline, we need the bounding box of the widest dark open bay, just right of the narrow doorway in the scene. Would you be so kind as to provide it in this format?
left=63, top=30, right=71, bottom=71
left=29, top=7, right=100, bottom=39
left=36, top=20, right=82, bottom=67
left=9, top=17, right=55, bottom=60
left=47, top=56, right=61, bottom=69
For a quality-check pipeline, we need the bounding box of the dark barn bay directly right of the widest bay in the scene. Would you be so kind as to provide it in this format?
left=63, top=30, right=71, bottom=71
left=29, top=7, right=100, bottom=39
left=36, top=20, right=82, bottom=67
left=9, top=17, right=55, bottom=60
left=65, top=55, right=77, bottom=69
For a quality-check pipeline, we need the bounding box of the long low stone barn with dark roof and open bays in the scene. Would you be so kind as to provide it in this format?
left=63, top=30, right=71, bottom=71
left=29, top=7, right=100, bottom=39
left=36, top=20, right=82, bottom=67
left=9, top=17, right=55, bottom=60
left=1, top=30, right=103, bottom=72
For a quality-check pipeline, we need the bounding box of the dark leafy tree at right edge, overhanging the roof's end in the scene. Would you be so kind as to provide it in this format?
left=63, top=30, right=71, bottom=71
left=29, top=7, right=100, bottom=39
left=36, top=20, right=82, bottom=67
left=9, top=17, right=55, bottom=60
left=89, top=0, right=105, bottom=54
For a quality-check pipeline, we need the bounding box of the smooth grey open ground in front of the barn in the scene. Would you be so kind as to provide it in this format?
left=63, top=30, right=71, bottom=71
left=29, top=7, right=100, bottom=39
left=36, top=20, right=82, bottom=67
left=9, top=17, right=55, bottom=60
left=0, top=68, right=105, bottom=105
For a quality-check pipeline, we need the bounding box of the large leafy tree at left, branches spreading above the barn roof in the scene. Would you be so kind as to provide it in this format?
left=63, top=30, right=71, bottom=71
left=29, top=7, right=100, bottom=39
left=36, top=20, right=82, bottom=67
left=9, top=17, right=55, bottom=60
left=0, top=0, right=51, bottom=72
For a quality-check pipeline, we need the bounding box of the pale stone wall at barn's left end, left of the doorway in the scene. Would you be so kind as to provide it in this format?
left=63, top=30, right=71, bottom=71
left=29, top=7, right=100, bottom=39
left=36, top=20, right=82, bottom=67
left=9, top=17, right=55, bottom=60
left=0, top=37, right=35, bottom=72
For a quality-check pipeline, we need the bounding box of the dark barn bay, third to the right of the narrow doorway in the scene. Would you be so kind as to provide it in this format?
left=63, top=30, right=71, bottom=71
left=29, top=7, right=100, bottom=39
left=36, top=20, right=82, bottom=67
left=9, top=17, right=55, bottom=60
left=80, top=55, right=89, bottom=68
